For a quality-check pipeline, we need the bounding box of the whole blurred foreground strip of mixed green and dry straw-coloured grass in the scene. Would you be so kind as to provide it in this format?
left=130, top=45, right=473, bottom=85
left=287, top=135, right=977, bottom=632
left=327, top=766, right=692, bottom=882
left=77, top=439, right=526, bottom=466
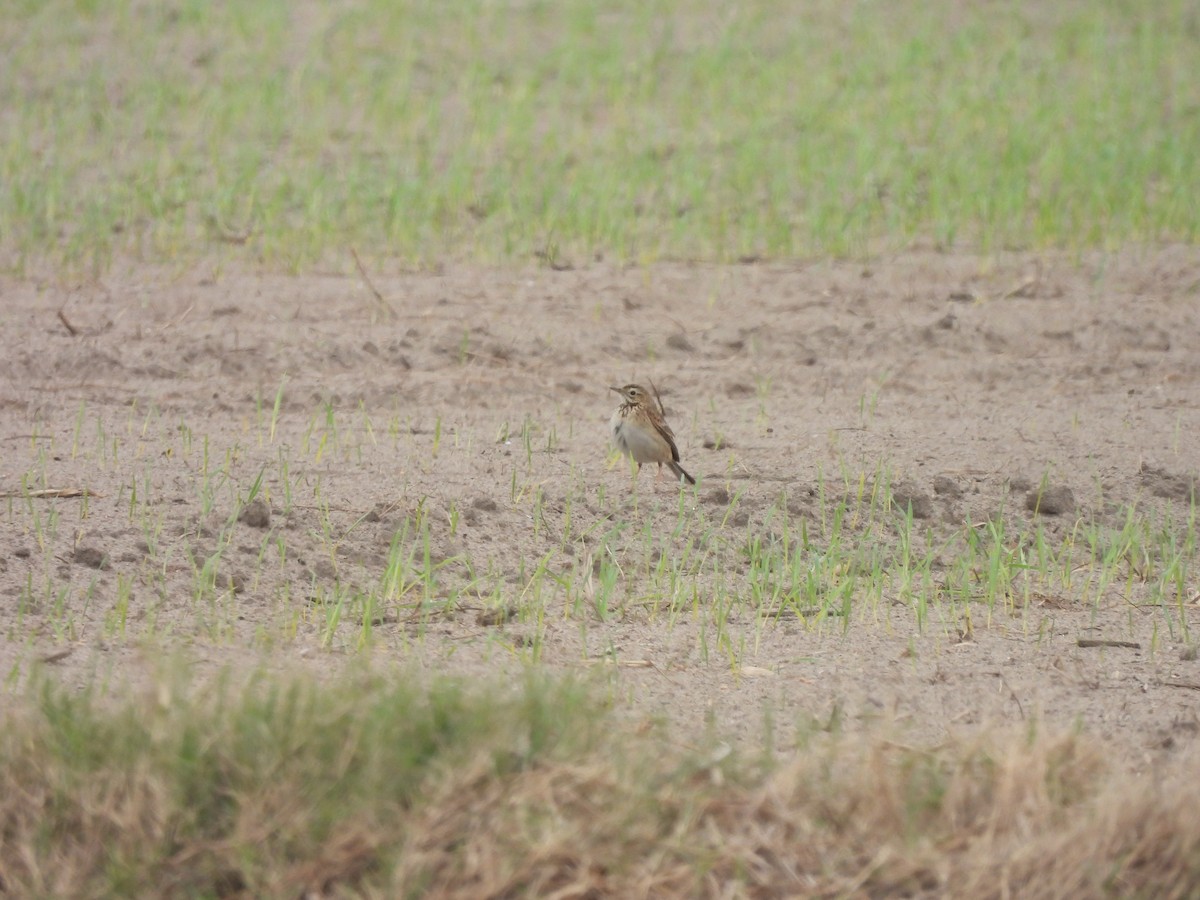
left=0, top=678, right=1200, bottom=898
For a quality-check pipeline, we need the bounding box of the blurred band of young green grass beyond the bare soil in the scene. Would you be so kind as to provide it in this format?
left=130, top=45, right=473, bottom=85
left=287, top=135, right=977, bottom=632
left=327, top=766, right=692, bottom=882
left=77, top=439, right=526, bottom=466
left=0, top=0, right=1200, bottom=271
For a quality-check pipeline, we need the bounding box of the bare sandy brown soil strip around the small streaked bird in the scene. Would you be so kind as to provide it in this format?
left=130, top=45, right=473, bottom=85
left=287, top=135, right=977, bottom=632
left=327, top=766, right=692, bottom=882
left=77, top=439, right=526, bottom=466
left=0, top=248, right=1200, bottom=769
